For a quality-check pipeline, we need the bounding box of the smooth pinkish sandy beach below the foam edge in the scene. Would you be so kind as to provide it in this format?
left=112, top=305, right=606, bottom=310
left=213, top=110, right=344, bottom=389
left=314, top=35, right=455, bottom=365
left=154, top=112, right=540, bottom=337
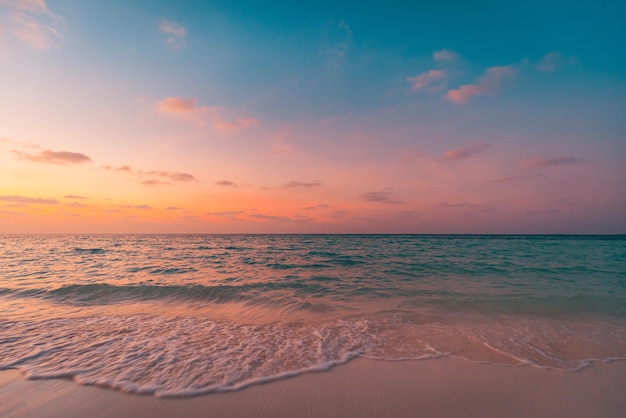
left=0, top=358, right=626, bottom=417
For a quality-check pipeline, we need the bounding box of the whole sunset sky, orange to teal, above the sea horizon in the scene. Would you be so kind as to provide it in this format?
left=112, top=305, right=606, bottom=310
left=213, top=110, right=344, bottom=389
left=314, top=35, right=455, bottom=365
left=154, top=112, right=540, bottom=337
left=0, top=0, right=626, bottom=234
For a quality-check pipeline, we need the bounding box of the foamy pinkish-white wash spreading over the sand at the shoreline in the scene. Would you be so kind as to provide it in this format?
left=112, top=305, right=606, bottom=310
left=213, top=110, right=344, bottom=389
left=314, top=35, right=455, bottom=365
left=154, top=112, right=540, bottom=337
left=0, top=315, right=626, bottom=397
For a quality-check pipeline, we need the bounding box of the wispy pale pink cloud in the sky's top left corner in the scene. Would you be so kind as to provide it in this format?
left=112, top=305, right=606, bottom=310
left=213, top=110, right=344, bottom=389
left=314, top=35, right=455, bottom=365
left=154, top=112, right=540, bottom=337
left=0, top=0, right=64, bottom=50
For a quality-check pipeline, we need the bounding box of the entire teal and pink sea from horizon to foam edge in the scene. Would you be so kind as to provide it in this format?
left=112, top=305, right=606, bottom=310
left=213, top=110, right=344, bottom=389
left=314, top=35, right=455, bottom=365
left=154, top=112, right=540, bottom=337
left=0, top=235, right=626, bottom=396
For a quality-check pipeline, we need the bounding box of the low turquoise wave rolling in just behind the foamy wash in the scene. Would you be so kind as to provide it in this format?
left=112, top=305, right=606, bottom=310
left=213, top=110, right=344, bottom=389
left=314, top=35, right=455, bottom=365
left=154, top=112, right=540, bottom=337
left=0, top=284, right=626, bottom=318
